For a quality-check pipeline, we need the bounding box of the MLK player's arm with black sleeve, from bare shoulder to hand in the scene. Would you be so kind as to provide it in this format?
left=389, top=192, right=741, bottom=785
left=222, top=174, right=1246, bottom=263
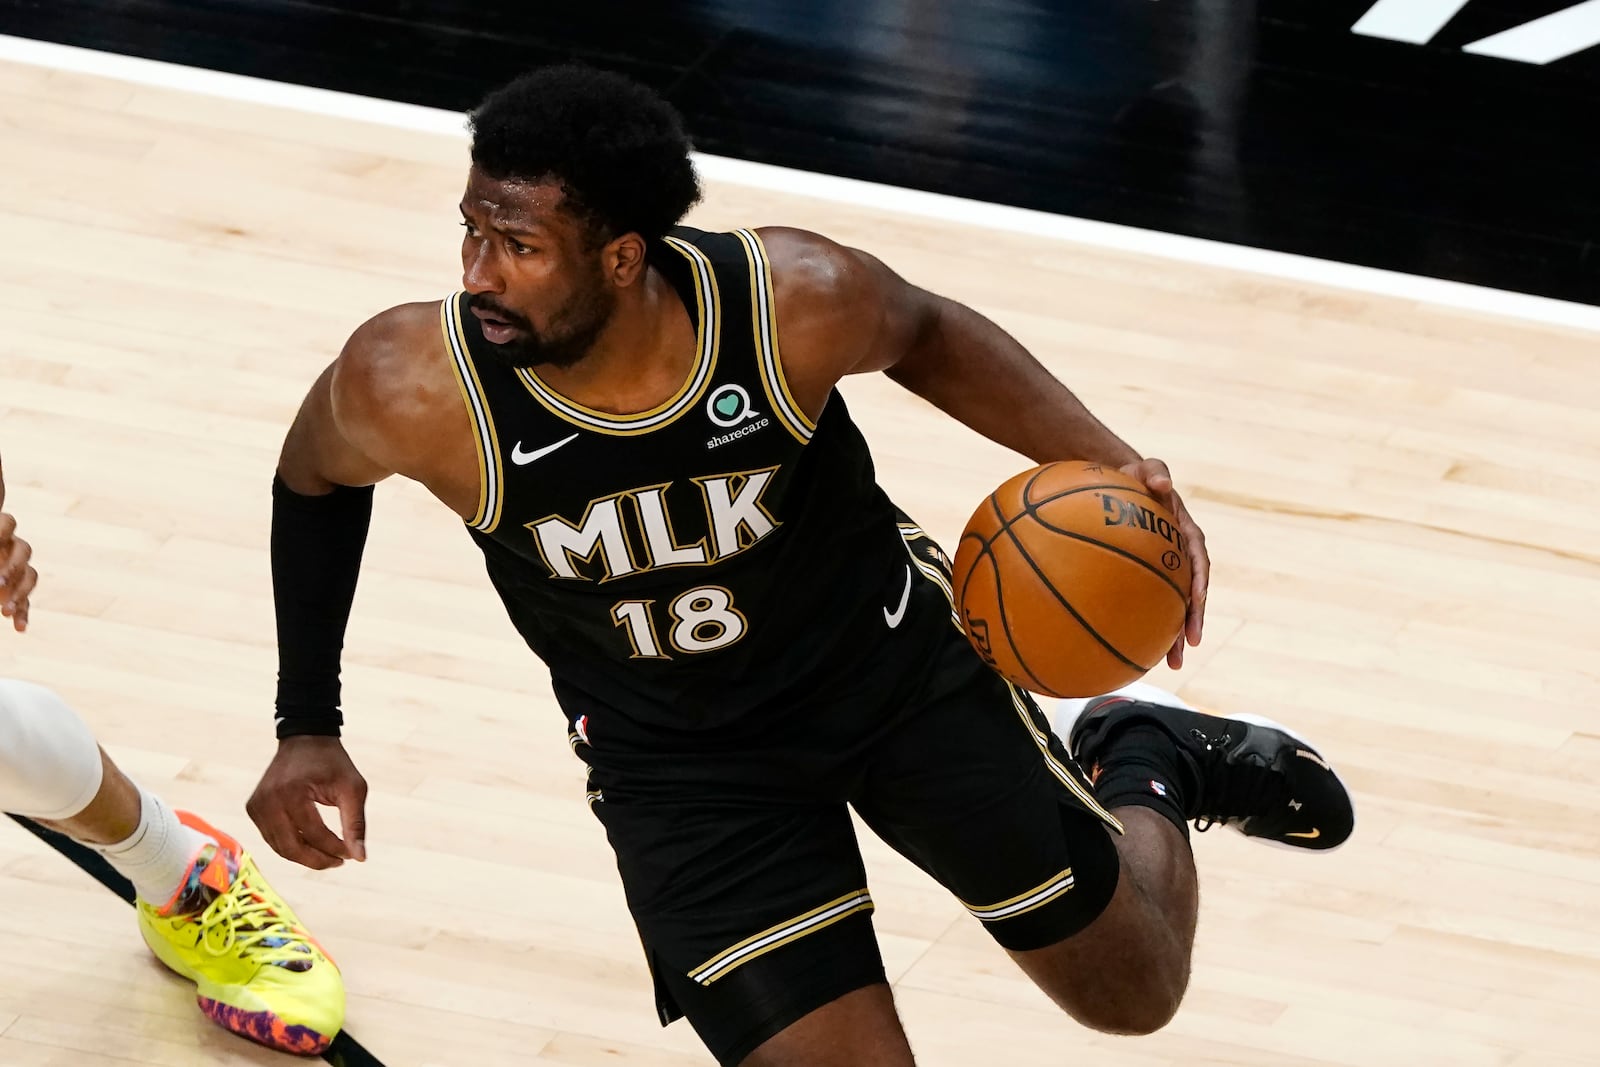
left=246, top=304, right=437, bottom=869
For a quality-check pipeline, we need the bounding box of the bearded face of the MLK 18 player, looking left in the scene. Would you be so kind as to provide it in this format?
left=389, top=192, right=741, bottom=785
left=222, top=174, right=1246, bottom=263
left=461, top=168, right=616, bottom=366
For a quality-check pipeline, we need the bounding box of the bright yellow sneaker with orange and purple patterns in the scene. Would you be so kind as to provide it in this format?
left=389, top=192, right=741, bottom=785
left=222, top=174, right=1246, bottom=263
left=139, top=811, right=344, bottom=1056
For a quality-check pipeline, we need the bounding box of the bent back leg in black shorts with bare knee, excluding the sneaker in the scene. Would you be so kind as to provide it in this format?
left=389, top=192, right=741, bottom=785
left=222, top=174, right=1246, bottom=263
left=854, top=652, right=1194, bottom=1033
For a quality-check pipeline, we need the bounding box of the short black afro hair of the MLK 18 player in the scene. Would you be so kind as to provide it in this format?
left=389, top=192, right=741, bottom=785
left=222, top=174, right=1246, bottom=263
left=469, top=66, right=701, bottom=242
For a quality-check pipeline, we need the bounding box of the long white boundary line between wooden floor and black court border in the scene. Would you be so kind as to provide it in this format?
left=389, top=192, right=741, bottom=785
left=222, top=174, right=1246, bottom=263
left=0, top=35, right=1600, bottom=333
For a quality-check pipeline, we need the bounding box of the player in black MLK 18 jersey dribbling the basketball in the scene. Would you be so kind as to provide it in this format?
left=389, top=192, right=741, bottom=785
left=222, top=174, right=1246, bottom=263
left=250, top=67, right=1352, bottom=1067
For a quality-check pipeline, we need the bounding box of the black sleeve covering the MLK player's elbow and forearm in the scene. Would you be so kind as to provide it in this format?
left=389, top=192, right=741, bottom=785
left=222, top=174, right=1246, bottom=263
left=272, top=477, right=373, bottom=739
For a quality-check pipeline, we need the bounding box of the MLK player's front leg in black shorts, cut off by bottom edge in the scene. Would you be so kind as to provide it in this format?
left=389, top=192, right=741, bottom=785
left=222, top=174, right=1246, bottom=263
left=590, top=757, right=912, bottom=1067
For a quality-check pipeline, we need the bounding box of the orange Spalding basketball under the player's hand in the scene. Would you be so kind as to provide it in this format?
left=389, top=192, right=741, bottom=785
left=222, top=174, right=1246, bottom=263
left=955, top=462, right=1189, bottom=696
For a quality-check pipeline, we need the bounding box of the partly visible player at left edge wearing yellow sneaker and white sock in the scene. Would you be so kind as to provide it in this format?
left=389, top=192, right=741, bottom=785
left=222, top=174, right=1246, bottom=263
left=0, top=454, right=344, bottom=1054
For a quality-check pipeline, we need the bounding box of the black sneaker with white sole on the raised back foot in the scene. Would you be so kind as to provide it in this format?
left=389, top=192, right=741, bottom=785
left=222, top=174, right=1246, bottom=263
left=1061, top=686, right=1355, bottom=851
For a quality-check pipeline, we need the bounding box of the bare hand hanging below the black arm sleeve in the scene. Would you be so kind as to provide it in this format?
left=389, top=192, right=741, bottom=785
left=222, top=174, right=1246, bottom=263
left=245, top=736, right=366, bottom=870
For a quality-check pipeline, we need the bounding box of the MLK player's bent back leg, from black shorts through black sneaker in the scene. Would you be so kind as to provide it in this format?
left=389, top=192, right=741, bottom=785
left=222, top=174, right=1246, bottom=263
left=856, top=649, right=1349, bottom=1033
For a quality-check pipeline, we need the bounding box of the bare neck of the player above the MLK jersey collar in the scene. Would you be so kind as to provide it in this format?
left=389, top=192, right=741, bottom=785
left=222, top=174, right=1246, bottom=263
left=536, top=269, right=696, bottom=414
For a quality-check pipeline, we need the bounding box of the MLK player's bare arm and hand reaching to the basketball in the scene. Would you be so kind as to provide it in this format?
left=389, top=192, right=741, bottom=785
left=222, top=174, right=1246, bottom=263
left=760, top=227, right=1210, bottom=667
